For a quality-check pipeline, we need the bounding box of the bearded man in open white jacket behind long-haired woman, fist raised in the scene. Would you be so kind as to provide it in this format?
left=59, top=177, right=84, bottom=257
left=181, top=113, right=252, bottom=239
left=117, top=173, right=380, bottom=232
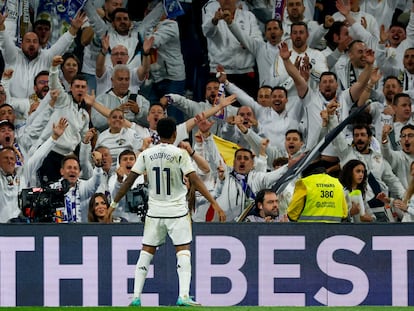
left=327, top=100, right=405, bottom=221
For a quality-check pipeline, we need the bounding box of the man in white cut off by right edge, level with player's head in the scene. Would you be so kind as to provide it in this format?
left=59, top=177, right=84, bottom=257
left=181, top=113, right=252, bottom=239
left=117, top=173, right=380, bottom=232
left=381, top=124, right=414, bottom=188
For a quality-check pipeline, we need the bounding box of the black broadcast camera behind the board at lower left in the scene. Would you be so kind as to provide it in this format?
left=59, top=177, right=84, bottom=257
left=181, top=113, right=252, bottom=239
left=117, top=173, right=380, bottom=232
left=19, top=184, right=65, bottom=222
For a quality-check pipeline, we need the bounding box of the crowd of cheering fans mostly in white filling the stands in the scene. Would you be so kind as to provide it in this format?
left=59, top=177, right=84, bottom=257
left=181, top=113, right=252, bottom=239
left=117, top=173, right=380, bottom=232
left=0, top=0, right=414, bottom=223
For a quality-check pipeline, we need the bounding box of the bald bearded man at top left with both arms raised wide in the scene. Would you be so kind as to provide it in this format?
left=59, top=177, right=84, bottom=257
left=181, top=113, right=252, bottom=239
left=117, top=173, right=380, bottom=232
left=0, top=13, right=85, bottom=98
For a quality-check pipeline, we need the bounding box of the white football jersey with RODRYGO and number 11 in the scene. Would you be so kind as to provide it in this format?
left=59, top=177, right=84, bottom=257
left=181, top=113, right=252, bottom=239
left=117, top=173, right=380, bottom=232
left=132, top=143, right=194, bottom=217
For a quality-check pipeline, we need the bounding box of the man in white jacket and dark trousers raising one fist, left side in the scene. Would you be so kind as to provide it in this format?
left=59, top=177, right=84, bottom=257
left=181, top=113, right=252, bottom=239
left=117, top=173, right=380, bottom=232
left=32, top=56, right=89, bottom=183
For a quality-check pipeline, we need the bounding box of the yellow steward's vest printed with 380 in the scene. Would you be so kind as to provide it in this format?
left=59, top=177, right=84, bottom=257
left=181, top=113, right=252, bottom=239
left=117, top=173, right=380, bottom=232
left=298, top=174, right=348, bottom=223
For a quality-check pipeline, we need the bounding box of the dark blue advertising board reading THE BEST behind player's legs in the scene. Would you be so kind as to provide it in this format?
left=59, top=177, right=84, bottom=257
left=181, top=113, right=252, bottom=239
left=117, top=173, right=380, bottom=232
left=0, top=223, right=414, bottom=306
